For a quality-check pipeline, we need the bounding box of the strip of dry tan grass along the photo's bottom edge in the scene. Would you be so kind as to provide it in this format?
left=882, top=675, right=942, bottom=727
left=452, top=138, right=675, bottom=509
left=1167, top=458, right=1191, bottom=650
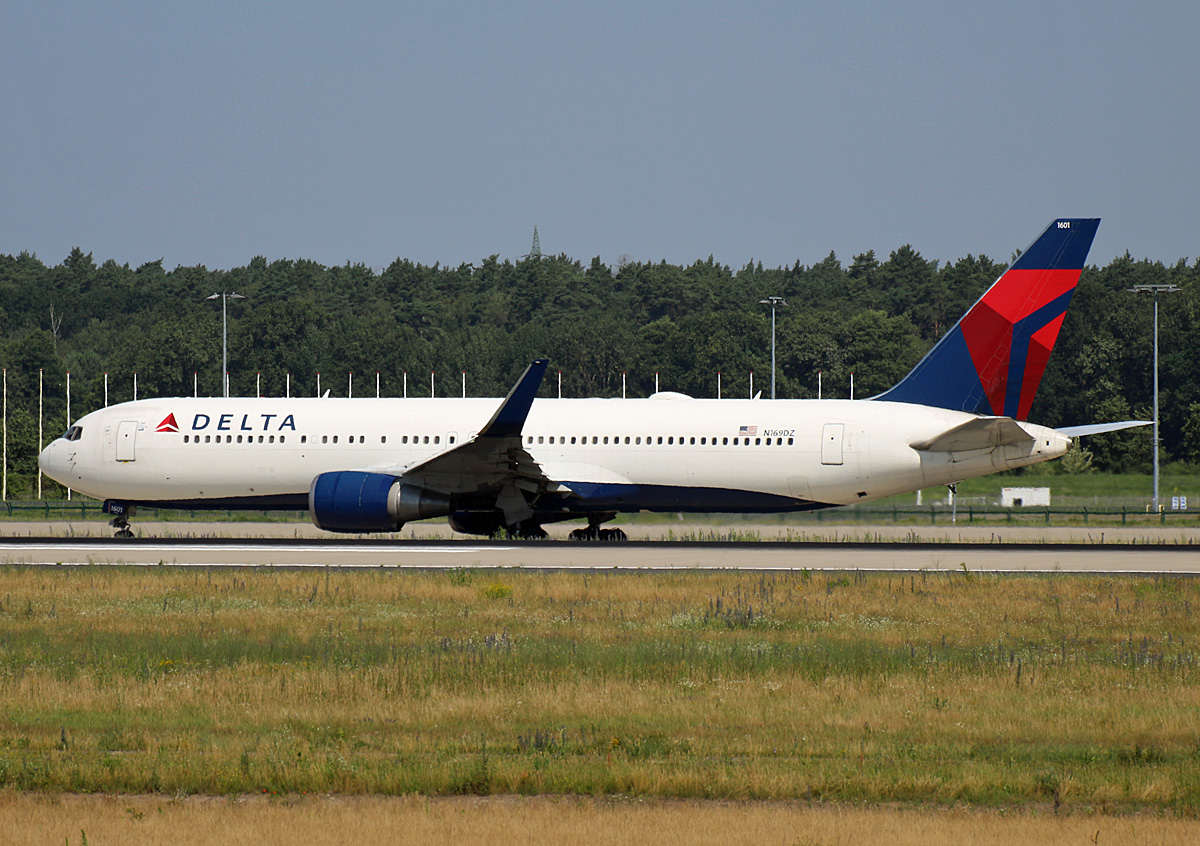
left=0, top=794, right=1200, bottom=846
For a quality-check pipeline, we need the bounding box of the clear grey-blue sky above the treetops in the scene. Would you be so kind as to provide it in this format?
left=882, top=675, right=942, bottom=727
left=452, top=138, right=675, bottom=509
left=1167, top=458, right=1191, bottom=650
left=0, top=0, right=1200, bottom=269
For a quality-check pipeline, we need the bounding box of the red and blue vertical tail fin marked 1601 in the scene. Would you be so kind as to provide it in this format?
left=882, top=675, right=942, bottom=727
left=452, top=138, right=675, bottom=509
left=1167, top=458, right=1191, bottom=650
left=872, top=217, right=1100, bottom=420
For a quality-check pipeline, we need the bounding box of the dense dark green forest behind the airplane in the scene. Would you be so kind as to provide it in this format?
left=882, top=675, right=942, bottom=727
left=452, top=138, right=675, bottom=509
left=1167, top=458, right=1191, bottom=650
left=0, top=246, right=1200, bottom=498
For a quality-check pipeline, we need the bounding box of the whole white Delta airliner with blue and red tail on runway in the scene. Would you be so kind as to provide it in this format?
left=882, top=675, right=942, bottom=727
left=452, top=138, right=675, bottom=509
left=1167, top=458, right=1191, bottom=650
left=38, top=218, right=1144, bottom=540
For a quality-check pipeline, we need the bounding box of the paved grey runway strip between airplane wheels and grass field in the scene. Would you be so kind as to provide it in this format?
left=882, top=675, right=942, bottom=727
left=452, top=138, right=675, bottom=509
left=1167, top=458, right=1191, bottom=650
left=0, top=538, right=1200, bottom=575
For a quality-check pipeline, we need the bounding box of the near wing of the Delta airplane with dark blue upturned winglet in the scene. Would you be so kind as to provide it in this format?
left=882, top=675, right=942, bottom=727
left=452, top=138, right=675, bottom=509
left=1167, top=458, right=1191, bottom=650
left=357, top=359, right=565, bottom=524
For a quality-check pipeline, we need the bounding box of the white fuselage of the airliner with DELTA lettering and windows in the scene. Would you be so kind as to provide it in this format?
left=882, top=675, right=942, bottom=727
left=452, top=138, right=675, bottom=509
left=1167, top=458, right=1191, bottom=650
left=41, top=398, right=1069, bottom=511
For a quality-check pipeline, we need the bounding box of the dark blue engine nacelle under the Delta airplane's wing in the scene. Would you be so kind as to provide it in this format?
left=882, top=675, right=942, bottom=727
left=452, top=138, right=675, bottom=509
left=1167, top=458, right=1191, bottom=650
left=308, top=470, right=451, bottom=533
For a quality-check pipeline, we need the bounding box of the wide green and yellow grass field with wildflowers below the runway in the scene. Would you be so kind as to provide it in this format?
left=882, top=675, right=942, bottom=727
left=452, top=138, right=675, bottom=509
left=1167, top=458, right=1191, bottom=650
left=0, top=568, right=1200, bottom=817
